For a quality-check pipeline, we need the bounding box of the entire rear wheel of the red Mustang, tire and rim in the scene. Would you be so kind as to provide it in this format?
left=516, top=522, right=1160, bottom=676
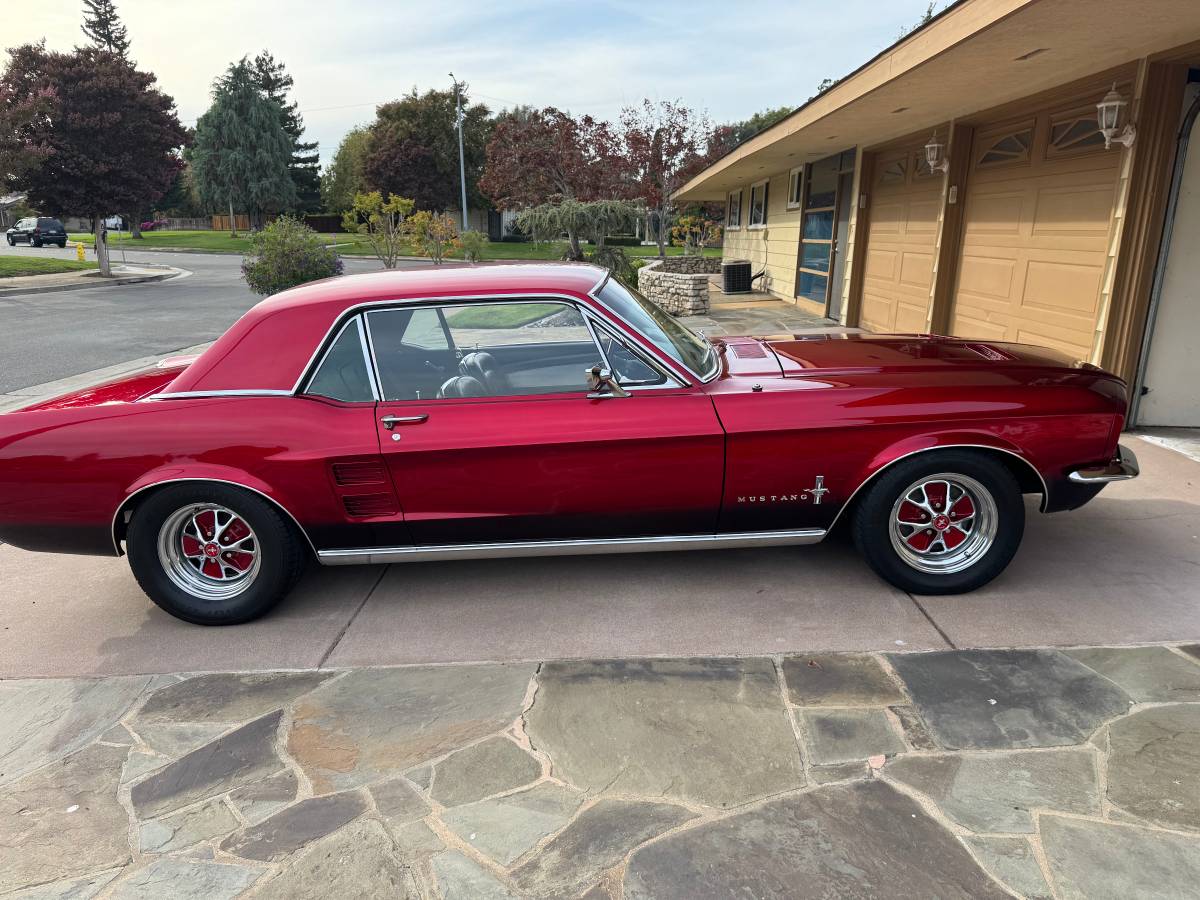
left=126, top=482, right=304, bottom=625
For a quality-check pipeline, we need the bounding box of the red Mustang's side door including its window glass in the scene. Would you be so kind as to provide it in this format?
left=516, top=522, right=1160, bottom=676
left=366, top=299, right=724, bottom=545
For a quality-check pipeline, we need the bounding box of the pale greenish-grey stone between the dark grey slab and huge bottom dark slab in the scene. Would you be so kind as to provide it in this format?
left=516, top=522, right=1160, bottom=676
left=884, top=750, right=1100, bottom=833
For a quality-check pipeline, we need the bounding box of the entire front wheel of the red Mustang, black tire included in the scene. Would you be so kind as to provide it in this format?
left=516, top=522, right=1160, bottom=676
left=852, top=450, right=1025, bottom=594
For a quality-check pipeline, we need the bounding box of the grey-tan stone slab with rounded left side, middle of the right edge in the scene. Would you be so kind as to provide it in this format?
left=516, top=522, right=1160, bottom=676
left=1108, top=703, right=1200, bottom=830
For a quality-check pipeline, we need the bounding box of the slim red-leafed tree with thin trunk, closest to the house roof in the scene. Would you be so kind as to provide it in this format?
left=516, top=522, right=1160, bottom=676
left=620, top=100, right=712, bottom=256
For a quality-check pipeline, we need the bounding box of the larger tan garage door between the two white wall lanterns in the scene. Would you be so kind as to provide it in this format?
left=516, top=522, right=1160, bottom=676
left=950, top=106, right=1121, bottom=359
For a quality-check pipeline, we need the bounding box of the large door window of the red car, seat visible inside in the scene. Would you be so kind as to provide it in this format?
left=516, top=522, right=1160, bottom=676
left=367, top=300, right=601, bottom=400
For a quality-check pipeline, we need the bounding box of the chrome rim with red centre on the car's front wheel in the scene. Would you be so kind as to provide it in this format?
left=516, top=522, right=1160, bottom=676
left=889, top=473, right=1000, bottom=575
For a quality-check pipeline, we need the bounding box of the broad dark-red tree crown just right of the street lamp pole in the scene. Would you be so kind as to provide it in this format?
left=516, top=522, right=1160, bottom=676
left=479, top=107, right=632, bottom=208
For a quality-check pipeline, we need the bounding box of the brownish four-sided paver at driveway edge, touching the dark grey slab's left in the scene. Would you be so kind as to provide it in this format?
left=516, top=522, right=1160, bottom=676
left=784, top=653, right=905, bottom=707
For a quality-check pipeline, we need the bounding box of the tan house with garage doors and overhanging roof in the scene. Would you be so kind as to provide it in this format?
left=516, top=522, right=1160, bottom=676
left=676, top=0, right=1200, bottom=426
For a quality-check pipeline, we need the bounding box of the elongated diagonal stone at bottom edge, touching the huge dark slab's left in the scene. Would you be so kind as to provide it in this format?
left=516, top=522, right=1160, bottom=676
left=512, top=800, right=695, bottom=900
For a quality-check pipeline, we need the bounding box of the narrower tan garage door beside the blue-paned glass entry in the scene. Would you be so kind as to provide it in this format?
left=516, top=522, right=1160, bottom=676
left=859, top=149, right=942, bottom=331
